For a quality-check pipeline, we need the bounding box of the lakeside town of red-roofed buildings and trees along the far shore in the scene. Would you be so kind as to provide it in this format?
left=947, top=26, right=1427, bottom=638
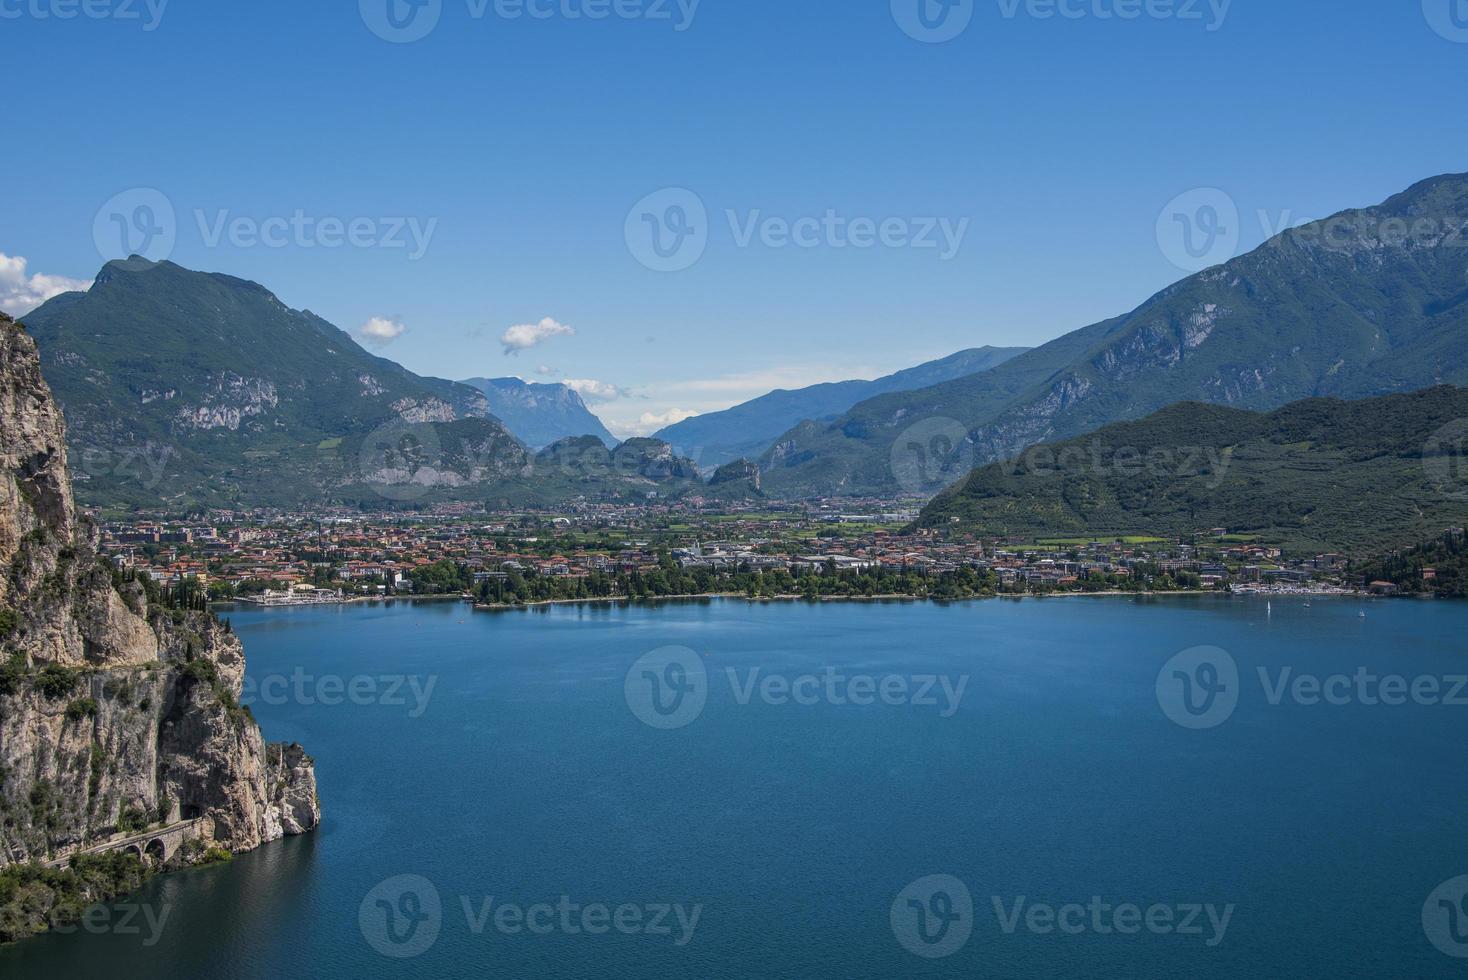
left=88, top=500, right=1464, bottom=606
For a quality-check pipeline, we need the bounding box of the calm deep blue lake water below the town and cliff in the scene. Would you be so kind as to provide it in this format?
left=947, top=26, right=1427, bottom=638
left=0, top=597, right=1468, bottom=980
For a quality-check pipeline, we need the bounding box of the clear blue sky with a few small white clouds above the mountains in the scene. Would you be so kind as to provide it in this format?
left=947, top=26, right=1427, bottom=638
left=0, top=0, right=1468, bottom=434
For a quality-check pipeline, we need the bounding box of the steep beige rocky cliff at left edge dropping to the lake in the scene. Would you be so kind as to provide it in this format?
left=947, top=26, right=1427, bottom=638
left=0, top=314, right=320, bottom=867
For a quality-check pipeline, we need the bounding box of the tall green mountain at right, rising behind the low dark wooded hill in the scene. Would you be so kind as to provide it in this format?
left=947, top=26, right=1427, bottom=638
left=760, top=175, right=1468, bottom=496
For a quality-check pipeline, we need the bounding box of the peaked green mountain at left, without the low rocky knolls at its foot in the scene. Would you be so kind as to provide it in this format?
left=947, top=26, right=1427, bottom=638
left=25, top=258, right=523, bottom=506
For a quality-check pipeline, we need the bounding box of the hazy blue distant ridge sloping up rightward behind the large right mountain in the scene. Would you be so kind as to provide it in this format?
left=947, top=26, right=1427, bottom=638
left=656, top=348, right=1026, bottom=469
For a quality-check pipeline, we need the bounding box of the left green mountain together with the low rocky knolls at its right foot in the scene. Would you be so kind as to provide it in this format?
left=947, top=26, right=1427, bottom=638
left=25, top=258, right=696, bottom=509
